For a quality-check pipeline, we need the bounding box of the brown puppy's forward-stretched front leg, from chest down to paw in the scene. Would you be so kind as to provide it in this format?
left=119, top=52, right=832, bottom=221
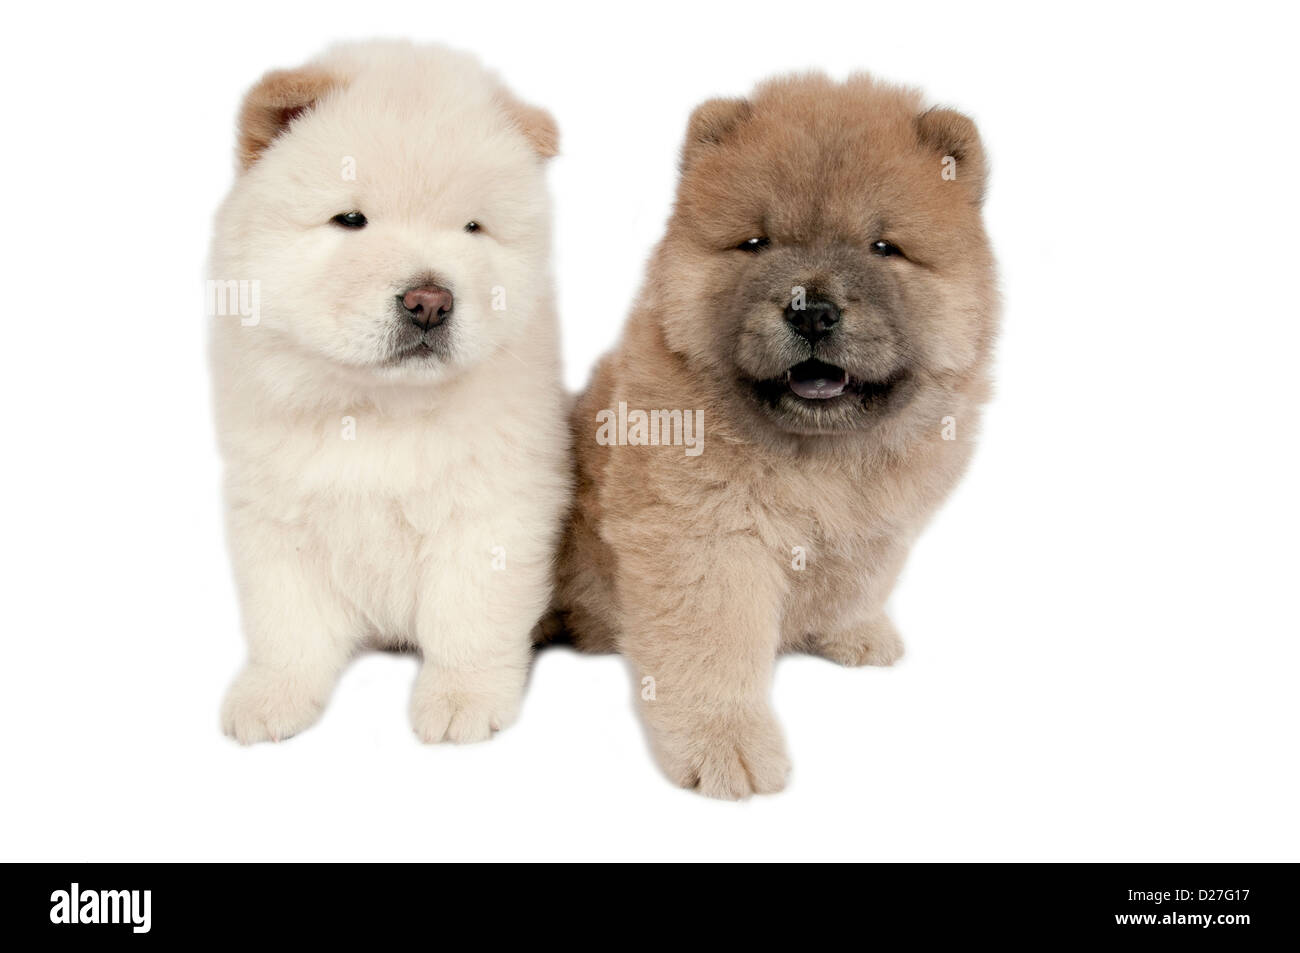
left=619, top=540, right=790, bottom=800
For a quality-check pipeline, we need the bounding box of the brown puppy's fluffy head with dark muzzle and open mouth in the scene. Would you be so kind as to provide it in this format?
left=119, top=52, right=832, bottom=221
left=649, top=75, right=996, bottom=434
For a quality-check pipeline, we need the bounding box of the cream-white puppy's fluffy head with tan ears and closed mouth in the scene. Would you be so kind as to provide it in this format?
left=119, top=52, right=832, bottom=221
left=212, top=43, right=556, bottom=384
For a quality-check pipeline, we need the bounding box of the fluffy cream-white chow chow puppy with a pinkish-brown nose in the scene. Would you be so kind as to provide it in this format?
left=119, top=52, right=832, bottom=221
left=209, top=44, right=569, bottom=742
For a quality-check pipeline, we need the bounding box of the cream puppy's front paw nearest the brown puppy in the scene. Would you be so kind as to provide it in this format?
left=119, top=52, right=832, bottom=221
left=411, top=664, right=523, bottom=745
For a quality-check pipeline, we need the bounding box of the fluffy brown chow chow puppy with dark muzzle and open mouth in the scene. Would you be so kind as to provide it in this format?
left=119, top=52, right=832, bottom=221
left=556, top=75, right=997, bottom=798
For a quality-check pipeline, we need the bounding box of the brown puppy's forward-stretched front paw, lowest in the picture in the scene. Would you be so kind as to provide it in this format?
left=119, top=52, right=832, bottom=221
left=649, top=702, right=790, bottom=801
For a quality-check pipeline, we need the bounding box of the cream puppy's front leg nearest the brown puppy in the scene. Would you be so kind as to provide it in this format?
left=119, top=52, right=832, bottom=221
left=411, top=527, right=550, bottom=744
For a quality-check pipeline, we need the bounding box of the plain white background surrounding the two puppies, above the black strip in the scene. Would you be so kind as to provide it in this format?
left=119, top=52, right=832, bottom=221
left=0, top=0, right=1300, bottom=861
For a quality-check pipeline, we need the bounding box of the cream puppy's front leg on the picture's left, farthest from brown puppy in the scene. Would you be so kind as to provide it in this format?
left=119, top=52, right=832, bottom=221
left=221, top=525, right=359, bottom=745
